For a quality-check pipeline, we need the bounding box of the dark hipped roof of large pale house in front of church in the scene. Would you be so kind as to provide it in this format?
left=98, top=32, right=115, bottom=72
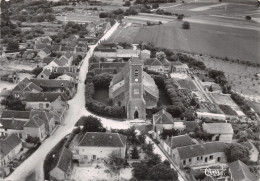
left=79, top=132, right=127, bottom=147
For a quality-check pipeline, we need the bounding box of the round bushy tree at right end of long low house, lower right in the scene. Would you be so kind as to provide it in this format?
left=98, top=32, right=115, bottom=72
left=224, top=143, right=249, bottom=163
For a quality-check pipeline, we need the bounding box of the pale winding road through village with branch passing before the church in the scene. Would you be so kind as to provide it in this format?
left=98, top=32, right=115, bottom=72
left=5, top=23, right=121, bottom=181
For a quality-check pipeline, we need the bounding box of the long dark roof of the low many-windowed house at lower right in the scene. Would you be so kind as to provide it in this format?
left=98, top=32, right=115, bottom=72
left=177, top=141, right=226, bottom=160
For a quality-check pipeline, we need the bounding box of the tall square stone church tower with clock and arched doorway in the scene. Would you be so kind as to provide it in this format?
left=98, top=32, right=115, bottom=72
left=127, top=59, right=146, bottom=119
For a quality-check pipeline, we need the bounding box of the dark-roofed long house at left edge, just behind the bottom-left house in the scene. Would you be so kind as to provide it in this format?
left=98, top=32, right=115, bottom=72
left=0, top=110, right=30, bottom=139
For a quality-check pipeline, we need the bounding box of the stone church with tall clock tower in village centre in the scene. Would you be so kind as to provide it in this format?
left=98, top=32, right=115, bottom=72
left=109, top=59, right=159, bottom=119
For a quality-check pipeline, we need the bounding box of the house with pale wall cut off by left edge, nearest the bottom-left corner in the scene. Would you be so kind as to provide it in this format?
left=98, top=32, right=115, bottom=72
left=0, top=134, right=22, bottom=167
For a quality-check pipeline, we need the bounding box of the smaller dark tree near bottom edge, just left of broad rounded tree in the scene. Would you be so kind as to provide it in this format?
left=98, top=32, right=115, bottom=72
left=132, top=161, right=149, bottom=180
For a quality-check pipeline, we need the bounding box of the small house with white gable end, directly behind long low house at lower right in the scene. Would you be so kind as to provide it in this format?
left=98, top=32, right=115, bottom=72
left=160, top=135, right=195, bottom=156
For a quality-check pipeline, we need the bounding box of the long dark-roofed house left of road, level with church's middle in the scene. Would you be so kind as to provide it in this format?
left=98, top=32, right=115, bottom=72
left=30, top=79, right=76, bottom=98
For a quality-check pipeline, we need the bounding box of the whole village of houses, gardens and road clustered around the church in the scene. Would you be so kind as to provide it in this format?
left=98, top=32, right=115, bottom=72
left=0, top=2, right=260, bottom=181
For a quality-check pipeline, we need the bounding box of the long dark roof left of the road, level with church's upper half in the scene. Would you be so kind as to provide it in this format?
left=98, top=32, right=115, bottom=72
left=31, top=79, right=74, bottom=88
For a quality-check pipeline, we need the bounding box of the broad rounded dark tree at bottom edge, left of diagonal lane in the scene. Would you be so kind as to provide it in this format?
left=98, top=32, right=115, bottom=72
left=147, top=163, right=178, bottom=180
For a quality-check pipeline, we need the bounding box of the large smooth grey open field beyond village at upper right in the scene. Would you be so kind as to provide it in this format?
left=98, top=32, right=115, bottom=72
left=110, top=22, right=260, bottom=63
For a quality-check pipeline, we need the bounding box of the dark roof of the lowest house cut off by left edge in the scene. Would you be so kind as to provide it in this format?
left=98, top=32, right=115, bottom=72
left=0, top=134, right=21, bottom=158
